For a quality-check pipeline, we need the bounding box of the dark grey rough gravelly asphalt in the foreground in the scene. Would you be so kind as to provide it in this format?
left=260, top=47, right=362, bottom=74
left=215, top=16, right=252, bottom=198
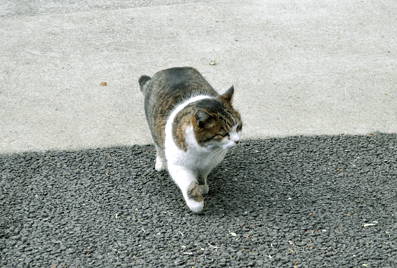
left=0, top=133, right=397, bottom=267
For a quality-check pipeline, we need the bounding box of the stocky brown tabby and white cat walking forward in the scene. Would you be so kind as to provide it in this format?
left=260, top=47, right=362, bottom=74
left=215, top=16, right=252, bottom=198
left=139, top=67, right=242, bottom=213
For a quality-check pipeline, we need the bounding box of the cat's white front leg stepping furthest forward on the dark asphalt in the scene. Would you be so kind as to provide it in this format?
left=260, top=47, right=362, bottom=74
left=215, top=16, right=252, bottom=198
left=168, top=165, right=204, bottom=213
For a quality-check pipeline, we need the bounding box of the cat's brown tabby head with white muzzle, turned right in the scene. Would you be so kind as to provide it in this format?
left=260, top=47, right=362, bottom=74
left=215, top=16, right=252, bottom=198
left=193, top=86, right=243, bottom=149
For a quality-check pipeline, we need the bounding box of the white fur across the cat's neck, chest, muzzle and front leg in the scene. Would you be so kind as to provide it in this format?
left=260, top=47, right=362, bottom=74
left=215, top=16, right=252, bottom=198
left=160, top=95, right=240, bottom=212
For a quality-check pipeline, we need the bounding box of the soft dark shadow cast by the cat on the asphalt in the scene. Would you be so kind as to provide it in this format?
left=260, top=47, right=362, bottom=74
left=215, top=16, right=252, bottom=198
left=153, top=142, right=285, bottom=216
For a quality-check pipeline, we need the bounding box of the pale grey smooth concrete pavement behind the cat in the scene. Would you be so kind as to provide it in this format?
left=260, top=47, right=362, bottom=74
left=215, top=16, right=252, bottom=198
left=0, top=0, right=397, bottom=153
